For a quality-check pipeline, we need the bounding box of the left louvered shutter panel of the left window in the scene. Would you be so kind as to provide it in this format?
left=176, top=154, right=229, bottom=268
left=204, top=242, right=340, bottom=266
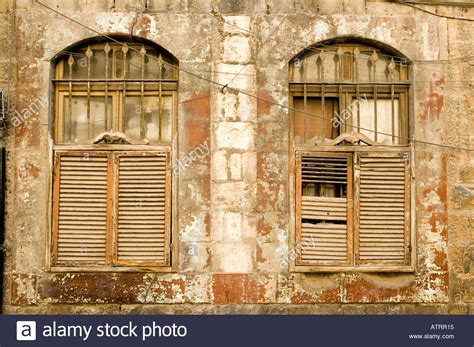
left=53, top=152, right=109, bottom=265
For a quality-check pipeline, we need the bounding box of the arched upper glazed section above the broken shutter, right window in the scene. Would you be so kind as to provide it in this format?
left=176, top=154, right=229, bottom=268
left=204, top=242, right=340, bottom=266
left=290, top=43, right=410, bottom=144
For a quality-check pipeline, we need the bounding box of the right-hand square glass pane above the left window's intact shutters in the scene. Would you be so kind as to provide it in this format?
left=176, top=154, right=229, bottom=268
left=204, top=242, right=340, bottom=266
left=123, top=96, right=172, bottom=143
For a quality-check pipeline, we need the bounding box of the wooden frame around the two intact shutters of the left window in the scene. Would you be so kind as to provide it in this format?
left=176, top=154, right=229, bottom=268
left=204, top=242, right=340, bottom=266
left=50, top=145, right=177, bottom=272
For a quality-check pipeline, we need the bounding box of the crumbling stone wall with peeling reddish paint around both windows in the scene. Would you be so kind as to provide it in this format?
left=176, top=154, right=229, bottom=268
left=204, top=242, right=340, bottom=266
left=0, top=0, right=474, bottom=314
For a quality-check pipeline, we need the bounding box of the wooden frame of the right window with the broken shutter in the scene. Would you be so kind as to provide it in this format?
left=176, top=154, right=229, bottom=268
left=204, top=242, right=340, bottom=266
left=288, top=43, right=417, bottom=273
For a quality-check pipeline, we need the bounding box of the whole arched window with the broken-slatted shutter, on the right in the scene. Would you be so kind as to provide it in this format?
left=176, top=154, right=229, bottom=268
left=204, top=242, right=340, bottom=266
left=290, top=40, right=413, bottom=271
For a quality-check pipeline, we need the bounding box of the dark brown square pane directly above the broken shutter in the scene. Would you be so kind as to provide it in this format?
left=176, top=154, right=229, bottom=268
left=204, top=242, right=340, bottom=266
left=293, top=97, right=340, bottom=140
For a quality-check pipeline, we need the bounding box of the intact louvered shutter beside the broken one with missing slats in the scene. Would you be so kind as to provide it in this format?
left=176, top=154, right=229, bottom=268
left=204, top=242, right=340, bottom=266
left=355, top=152, right=410, bottom=266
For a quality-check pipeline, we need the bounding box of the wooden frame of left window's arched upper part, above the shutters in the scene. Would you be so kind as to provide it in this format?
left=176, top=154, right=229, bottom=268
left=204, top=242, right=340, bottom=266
left=52, top=42, right=179, bottom=145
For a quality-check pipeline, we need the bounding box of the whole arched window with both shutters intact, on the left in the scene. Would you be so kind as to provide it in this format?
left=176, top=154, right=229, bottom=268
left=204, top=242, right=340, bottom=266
left=52, top=40, right=178, bottom=269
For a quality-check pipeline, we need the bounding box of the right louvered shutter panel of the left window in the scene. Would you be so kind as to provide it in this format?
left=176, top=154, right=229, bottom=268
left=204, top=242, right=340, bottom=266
left=116, top=152, right=170, bottom=266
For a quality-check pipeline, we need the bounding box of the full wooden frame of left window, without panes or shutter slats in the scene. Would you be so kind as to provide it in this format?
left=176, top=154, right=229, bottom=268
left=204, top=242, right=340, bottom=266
left=51, top=42, right=179, bottom=272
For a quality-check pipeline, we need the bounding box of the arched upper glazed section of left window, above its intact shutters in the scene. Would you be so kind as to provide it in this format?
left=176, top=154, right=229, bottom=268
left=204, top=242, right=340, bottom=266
left=53, top=42, right=178, bottom=144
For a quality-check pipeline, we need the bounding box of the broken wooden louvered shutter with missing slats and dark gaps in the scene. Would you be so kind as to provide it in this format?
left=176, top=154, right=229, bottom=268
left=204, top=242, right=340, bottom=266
left=296, top=152, right=352, bottom=265
